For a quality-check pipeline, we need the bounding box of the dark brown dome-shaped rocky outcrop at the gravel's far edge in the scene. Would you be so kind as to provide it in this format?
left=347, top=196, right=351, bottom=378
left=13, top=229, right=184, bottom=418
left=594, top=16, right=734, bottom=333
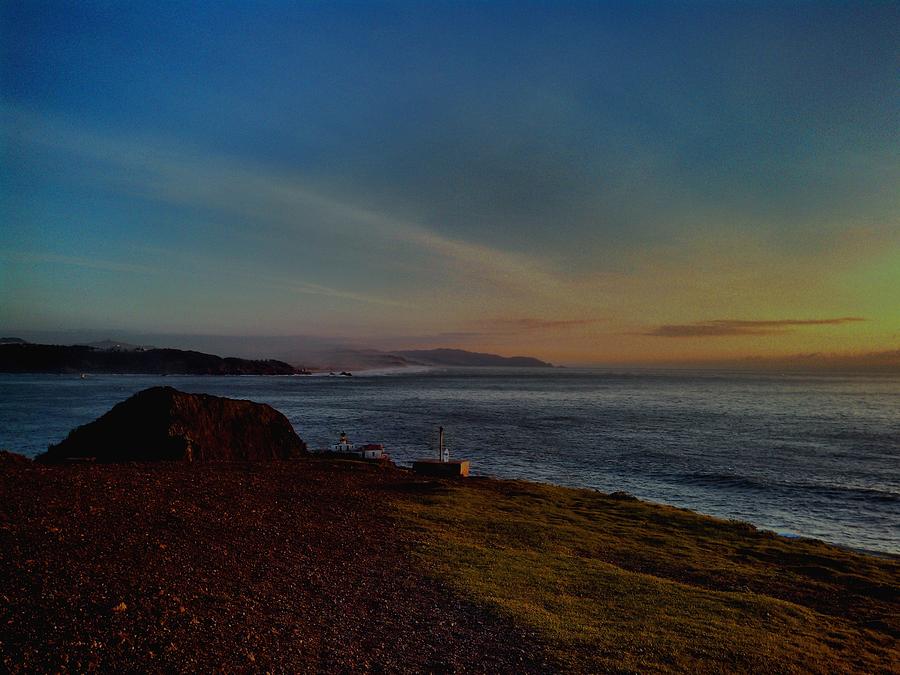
left=37, top=387, right=306, bottom=462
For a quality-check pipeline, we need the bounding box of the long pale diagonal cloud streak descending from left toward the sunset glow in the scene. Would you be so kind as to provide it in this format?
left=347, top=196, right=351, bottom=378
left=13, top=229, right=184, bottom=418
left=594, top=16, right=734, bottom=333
left=7, top=110, right=568, bottom=298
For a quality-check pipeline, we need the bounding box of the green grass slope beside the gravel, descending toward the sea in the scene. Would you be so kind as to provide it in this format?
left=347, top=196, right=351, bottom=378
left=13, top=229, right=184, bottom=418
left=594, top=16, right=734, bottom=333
left=396, top=480, right=900, bottom=673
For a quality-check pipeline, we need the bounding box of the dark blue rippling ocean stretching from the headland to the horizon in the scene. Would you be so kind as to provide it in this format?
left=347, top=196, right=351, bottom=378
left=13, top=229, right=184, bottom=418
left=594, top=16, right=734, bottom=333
left=0, top=368, right=900, bottom=554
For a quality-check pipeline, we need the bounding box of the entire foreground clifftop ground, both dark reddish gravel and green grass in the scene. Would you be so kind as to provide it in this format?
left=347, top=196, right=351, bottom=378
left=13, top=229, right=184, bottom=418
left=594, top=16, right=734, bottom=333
left=0, top=458, right=900, bottom=672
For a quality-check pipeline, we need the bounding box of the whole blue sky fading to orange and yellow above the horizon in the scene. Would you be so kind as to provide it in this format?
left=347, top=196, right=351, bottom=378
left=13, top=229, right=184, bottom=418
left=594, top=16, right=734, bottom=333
left=0, top=0, right=900, bottom=364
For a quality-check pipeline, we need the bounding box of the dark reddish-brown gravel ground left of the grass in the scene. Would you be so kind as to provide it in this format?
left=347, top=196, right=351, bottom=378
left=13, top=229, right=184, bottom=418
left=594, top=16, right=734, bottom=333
left=0, top=456, right=552, bottom=673
